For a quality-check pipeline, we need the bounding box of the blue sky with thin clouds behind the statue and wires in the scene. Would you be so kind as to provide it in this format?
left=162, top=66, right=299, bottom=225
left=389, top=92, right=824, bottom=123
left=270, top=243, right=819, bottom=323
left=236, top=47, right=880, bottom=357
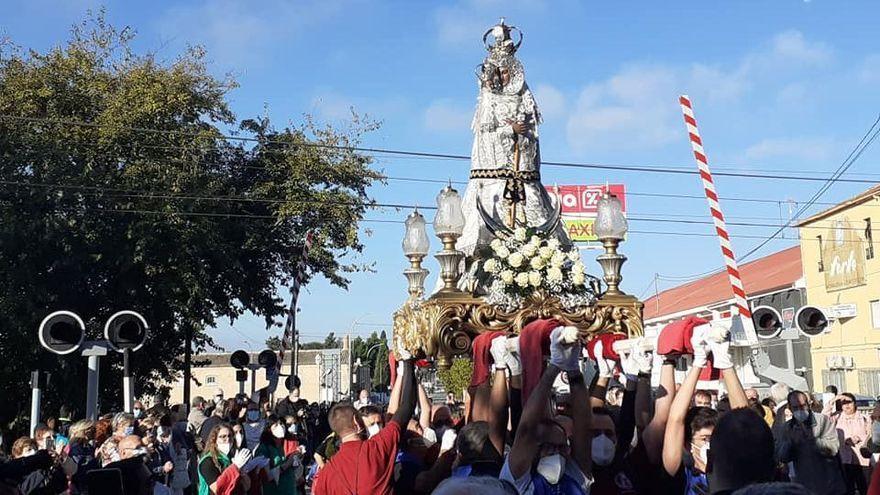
left=0, top=0, right=880, bottom=351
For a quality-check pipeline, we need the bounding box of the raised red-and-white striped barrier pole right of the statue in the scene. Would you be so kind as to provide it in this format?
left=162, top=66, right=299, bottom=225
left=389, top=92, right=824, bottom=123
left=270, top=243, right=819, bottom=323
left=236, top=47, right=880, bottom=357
left=678, top=95, right=758, bottom=343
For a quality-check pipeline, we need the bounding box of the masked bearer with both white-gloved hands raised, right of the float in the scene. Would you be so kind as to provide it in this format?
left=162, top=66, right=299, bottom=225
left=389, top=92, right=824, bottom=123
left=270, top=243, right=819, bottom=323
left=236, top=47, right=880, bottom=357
left=662, top=322, right=748, bottom=495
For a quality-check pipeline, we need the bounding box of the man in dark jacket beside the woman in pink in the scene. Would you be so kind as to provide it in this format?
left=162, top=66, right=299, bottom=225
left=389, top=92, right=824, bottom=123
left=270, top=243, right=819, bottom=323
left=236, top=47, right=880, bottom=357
left=773, top=390, right=847, bottom=495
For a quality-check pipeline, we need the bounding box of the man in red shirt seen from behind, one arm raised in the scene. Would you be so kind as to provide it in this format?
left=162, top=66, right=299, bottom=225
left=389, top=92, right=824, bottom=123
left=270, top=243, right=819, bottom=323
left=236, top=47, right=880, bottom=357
left=313, top=360, right=416, bottom=495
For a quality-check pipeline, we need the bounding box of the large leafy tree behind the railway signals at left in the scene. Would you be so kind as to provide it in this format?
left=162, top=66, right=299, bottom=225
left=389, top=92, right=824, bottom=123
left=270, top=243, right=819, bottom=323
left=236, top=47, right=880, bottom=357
left=0, top=13, right=377, bottom=420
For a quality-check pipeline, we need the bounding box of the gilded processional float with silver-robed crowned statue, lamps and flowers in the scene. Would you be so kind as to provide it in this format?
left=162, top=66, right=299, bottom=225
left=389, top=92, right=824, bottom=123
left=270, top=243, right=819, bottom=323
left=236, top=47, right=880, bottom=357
left=393, top=19, right=643, bottom=369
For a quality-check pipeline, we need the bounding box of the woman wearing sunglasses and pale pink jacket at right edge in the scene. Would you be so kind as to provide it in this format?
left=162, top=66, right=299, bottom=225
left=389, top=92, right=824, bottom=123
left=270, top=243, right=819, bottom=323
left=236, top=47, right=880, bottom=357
left=831, top=392, right=871, bottom=493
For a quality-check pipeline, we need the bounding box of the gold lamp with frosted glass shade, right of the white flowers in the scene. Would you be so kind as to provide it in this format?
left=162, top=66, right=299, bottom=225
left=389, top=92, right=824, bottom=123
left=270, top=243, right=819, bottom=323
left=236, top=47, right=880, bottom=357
left=593, top=192, right=628, bottom=296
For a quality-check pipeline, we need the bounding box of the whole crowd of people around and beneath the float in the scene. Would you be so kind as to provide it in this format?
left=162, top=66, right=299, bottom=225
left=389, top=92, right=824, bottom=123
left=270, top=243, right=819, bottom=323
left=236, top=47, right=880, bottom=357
left=0, top=320, right=880, bottom=495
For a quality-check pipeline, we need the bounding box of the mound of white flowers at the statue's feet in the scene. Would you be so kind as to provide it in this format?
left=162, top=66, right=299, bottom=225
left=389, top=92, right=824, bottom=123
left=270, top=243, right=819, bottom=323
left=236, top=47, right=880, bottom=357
left=476, top=227, right=598, bottom=310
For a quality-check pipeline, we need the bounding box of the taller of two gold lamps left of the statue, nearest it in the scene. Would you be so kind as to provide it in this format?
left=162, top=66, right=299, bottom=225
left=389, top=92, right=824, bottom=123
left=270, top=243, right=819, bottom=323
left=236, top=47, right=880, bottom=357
left=434, top=185, right=464, bottom=293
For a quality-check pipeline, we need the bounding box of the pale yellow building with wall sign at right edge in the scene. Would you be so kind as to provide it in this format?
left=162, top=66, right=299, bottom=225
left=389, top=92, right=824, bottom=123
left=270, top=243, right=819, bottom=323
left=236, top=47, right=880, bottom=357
left=798, top=186, right=880, bottom=397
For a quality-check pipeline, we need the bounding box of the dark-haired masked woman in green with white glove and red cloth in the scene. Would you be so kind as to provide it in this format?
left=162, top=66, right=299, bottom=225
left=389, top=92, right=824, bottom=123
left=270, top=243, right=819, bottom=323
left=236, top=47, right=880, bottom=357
left=198, top=423, right=251, bottom=495
